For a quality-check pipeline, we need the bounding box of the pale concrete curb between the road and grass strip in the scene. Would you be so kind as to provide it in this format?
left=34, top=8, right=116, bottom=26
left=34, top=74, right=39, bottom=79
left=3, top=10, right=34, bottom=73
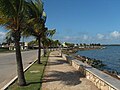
left=0, top=59, right=37, bottom=90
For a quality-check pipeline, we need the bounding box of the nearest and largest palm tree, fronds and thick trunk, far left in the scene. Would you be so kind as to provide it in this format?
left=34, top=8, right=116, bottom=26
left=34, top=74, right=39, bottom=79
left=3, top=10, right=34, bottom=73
left=0, top=0, right=26, bottom=86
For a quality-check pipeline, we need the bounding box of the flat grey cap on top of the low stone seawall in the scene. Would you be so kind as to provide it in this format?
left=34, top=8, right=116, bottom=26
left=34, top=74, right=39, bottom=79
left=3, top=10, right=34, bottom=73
left=67, top=56, right=120, bottom=90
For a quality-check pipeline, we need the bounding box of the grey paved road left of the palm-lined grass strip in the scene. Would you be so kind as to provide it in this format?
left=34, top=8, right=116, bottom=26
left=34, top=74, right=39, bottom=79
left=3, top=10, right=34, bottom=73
left=0, top=50, right=43, bottom=88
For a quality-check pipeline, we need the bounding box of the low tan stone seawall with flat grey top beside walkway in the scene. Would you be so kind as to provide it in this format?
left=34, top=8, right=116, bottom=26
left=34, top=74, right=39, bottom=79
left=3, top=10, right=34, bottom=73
left=62, top=54, right=120, bottom=90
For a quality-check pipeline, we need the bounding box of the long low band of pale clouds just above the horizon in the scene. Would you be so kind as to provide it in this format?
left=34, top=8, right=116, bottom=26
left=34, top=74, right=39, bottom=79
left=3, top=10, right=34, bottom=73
left=59, top=31, right=120, bottom=43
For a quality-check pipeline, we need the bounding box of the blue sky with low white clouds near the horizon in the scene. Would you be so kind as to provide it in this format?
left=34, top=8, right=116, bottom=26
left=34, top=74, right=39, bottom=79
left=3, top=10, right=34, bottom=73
left=0, top=0, right=120, bottom=44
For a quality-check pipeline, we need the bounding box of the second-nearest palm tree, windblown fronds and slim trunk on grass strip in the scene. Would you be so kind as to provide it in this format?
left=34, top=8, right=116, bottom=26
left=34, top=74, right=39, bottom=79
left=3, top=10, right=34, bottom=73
left=25, top=0, right=46, bottom=64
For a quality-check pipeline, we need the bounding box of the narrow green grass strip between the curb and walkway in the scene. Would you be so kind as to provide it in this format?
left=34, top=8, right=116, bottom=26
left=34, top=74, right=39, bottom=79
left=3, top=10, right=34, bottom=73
left=7, top=53, right=49, bottom=90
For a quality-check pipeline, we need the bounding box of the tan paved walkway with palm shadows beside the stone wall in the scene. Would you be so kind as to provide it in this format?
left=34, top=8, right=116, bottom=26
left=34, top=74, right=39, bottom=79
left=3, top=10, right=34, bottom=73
left=42, top=51, right=99, bottom=90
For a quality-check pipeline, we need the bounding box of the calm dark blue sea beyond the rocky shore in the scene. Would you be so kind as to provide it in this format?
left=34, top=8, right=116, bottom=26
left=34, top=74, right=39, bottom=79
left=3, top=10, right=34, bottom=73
left=77, top=46, right=120, bottom=73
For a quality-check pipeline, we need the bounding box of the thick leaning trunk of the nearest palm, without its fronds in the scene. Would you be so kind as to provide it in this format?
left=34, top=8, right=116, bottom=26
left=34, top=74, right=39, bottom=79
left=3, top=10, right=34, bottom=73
left=14, top=31, right=26, bottom=86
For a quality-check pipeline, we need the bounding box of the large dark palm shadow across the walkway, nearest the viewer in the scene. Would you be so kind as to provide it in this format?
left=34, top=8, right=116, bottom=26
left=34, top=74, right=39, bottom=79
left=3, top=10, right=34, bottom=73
left=42, top=71, right=84, bottom=86
